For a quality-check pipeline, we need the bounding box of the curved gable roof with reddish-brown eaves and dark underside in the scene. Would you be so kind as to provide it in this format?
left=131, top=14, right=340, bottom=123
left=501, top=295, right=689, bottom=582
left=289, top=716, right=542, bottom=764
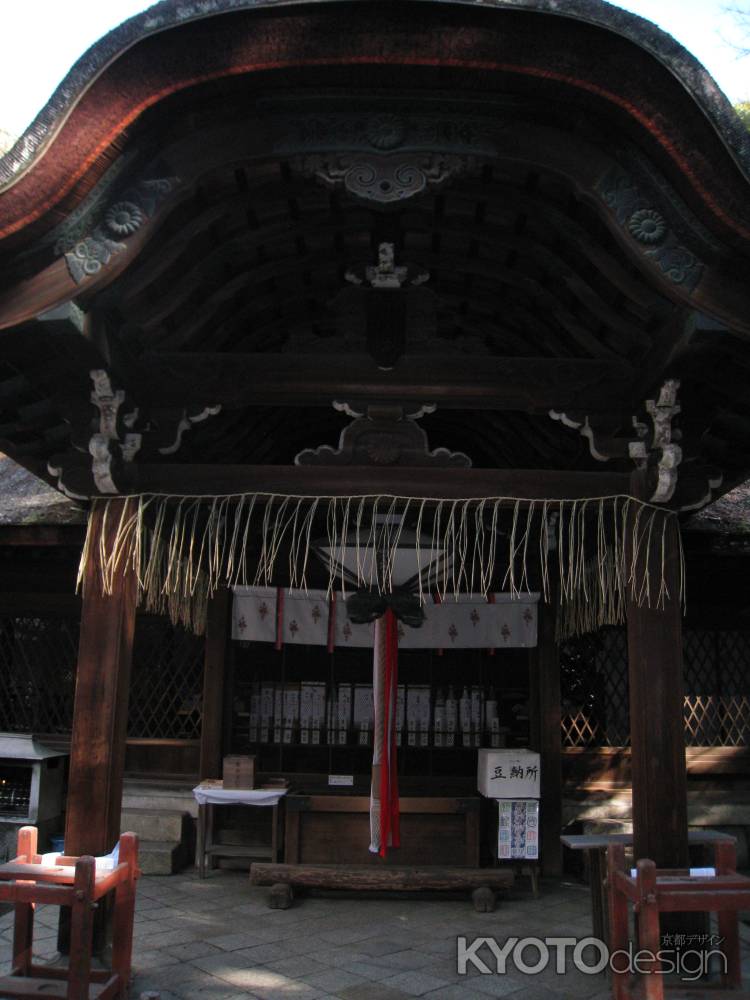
left=0, top=0, right=750, bottom=505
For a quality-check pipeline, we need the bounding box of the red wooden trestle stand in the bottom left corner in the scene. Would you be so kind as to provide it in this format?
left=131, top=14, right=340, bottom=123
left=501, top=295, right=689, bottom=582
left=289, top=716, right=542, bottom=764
left=0, top=826, right=140, bottom=1000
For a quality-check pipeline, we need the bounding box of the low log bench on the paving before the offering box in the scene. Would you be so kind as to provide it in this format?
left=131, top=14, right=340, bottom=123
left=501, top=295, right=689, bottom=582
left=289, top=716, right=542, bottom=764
left=250, top=863, right=514, bottom=913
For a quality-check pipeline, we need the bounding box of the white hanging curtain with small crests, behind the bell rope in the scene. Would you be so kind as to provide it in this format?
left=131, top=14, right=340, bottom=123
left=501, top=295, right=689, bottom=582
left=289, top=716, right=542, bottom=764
left=232, top=587, right=539, bottom=649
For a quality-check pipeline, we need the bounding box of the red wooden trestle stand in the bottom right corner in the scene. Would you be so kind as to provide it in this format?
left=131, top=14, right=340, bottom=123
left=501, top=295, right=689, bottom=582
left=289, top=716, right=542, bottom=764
left=607, top=841, right=750, bottom=1000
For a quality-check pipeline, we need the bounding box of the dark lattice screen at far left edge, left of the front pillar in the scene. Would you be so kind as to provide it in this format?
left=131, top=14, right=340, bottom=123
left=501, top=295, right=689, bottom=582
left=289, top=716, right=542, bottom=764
left=0, top=614, right=78, bottom=733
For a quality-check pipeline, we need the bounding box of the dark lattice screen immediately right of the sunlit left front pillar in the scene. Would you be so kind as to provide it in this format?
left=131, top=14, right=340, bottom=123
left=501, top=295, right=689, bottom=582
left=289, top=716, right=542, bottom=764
left=128, top=616, right=204, bottom=739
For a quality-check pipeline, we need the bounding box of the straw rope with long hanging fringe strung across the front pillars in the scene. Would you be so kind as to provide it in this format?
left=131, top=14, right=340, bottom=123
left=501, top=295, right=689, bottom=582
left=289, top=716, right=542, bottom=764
left=78, top=493, right=685, bottom=638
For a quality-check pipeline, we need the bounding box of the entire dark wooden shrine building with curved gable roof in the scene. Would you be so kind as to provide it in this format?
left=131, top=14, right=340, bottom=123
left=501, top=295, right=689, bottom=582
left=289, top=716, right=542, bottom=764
left=0, top=0, right=750, bottom=888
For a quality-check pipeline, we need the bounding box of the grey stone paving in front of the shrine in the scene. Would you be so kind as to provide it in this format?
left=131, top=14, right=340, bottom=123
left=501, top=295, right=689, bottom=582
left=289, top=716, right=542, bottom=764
left=0, top=870, right=750, bottom=1000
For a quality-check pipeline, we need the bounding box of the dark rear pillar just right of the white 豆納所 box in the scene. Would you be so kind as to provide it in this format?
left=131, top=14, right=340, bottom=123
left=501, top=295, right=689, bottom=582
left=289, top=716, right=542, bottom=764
left=529, top=593, right=562, bottom=875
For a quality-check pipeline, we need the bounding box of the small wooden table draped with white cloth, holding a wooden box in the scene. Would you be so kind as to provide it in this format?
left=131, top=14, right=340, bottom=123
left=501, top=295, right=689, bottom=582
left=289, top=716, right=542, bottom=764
left=193, top=784, right=287, bottom=878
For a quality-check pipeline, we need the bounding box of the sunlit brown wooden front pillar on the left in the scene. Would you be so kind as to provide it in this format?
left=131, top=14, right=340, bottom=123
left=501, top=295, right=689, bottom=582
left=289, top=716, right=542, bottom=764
left=65, top=500, right=137, bottom=855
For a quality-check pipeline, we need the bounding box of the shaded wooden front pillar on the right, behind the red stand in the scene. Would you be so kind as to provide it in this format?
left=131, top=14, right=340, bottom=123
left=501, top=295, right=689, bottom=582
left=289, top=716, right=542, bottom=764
left=628, top=473, right=688, bottom=868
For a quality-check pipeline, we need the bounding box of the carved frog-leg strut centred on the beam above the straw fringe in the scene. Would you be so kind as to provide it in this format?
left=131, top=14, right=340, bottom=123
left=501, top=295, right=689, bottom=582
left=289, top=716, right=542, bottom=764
left=294, top=403, right=471, bottom=469
